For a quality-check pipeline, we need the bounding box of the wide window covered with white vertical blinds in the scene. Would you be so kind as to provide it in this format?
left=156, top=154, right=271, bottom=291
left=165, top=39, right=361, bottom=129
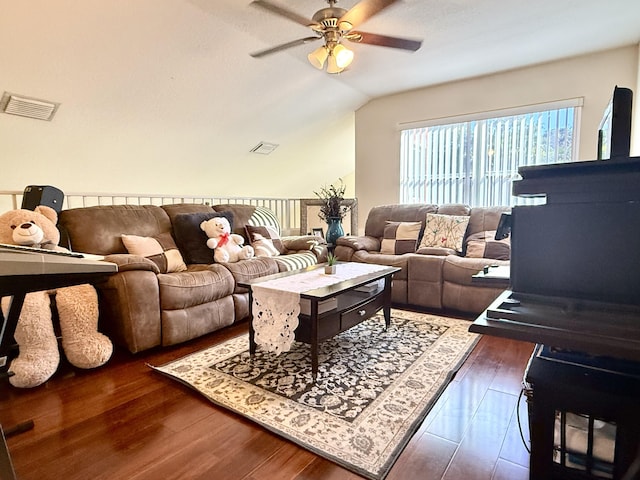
left=400, top=99, right=581, bottom=206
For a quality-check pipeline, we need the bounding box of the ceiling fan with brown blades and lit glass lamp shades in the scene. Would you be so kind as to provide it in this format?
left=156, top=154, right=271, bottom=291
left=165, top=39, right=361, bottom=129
left=251, top=0, right=422, bottom=73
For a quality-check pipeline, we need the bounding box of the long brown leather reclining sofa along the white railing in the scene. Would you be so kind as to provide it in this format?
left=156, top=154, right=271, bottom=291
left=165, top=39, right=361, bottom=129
left=58, top=204, right=326, bottom=353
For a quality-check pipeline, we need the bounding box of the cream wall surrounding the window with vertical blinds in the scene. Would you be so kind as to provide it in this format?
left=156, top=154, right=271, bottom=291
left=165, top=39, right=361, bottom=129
left=356, top=46, right=640, bottom=231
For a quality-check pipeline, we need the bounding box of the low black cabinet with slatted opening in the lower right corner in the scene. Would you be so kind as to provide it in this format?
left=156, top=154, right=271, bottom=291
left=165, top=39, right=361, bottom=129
left=524, top=345, right=640, bottom=480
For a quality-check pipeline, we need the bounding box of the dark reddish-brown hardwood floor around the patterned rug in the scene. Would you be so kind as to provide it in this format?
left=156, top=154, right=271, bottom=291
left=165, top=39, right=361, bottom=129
left=0, top=316, right=533, bottom=480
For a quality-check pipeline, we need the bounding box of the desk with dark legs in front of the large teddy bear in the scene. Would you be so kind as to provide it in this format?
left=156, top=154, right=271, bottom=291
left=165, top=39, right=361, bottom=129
left=0, top=249, right=118, bottom=480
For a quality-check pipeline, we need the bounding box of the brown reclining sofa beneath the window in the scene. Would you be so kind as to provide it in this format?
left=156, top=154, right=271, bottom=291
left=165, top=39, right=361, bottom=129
left=335, top=204, right=510, bottom=314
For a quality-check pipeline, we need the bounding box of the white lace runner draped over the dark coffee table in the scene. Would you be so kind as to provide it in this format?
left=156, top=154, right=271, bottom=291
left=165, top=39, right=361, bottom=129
left=251, top=263, right=386, bottom=355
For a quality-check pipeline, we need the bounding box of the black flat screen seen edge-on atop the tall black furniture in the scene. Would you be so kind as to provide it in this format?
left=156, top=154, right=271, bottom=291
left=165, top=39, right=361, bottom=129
left=598, top=86, right=633, bottom=160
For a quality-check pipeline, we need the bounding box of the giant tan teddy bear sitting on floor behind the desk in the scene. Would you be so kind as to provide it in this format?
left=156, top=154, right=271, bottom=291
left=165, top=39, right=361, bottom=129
left=0, top=205, right=113, bottom=388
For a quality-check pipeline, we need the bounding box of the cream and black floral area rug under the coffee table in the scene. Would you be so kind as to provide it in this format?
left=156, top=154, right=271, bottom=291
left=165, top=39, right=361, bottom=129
left=152, top=310, right=478, bottom=480
